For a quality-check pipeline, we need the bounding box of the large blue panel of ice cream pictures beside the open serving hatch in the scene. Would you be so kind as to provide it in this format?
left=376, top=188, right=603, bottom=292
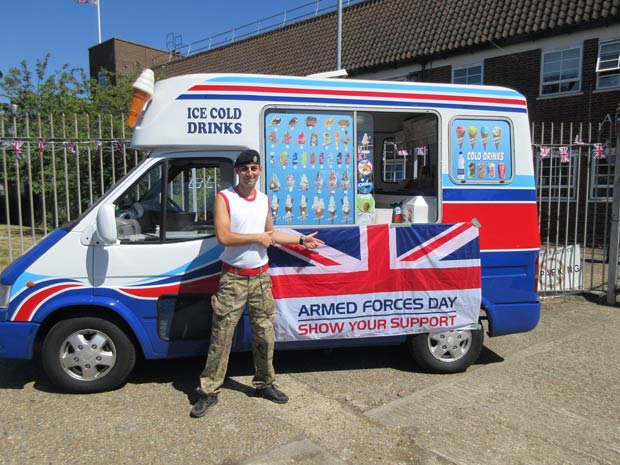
left=265, top=109, right=355, bottom=225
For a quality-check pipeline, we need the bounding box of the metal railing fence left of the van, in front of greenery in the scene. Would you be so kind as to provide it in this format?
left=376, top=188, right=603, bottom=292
left=0, top=113, right=144, bottom=261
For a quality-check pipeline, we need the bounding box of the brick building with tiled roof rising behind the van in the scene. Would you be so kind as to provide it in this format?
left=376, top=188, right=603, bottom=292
left=128, top=0, right=620, bottom=126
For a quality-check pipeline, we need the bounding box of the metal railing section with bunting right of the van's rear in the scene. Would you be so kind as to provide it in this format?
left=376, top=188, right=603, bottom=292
left=532, top=119, right=617, bottom=296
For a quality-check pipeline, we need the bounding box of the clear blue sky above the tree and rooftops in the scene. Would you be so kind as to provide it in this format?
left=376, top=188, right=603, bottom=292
left=0, top=0, right=330, bottom=80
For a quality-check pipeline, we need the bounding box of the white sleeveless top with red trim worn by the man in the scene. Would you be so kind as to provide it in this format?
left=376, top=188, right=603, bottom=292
left=218, top=187, right=269, bottom=268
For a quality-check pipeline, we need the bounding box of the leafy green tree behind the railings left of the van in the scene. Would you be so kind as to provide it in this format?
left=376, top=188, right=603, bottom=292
left=0, top=53, right=143, bottom=227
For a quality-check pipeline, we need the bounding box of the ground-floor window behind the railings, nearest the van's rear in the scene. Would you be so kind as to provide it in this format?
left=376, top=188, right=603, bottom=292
left=537, top=156, right=578, bottom=201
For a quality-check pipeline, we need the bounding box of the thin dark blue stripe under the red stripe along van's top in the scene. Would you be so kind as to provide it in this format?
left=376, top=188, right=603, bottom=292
left=177, top=93, right=527, bottom=113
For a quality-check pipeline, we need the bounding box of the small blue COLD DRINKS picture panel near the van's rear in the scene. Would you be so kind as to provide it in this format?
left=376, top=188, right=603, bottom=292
left=450, top=118, right=512, bottom=184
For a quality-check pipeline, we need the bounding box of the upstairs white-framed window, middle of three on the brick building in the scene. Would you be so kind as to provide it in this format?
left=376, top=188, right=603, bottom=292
left=540, top=48, right=581, bottom=95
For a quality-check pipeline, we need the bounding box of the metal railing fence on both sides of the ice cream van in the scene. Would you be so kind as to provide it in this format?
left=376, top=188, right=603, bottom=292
left=0, top=114, right=617, bottom=297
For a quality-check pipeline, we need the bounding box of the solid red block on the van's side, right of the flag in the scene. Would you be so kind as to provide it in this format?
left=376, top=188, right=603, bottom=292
left=442, top=202, right=540, bottom=250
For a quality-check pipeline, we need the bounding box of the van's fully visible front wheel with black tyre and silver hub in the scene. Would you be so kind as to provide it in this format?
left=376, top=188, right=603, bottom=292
left=41, top=317, right=136, bottom=393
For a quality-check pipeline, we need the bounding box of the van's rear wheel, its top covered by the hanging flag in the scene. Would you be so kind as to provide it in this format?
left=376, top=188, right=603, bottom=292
left=407, top=329, right=484, bottom=374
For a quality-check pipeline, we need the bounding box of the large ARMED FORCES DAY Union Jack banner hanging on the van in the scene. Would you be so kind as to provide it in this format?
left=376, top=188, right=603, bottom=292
left=269, top=223, right=481, bottom=340
